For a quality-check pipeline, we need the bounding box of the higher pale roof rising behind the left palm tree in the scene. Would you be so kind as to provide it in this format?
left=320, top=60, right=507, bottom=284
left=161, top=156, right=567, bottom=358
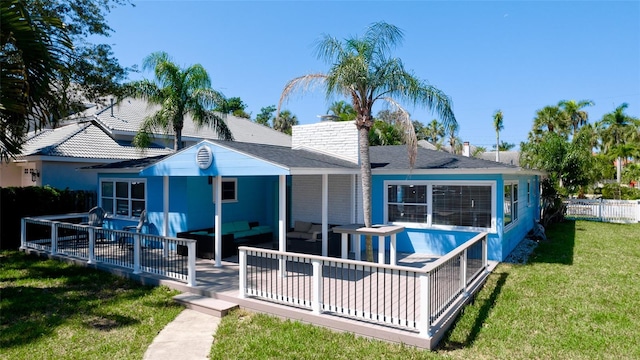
left=84, top=98, right=291, bottom=146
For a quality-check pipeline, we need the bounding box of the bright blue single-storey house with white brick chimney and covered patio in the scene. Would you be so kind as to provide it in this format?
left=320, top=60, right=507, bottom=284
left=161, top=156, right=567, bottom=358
left=84, top=121, right=543, bottom=261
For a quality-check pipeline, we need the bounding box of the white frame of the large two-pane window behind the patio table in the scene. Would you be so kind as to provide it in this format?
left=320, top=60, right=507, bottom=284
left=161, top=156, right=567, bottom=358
left=383, top=180, right=497, bottom=232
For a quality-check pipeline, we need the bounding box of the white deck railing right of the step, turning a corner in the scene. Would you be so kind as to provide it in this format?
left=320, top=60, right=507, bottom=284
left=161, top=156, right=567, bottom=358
left=239, top=233, right=488, bottom=337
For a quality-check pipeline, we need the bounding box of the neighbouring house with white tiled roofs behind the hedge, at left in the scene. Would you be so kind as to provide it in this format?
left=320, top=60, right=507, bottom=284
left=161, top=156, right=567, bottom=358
left=0, top=98, right=291, bottom=190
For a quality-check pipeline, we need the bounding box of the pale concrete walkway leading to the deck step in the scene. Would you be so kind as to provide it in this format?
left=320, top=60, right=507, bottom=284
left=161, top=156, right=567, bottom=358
left=144, top=309, right=220, bottom=360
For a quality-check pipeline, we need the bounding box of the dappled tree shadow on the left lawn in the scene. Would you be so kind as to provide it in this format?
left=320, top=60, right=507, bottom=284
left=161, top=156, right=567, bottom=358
left=0, top=252, right=175, bottom=349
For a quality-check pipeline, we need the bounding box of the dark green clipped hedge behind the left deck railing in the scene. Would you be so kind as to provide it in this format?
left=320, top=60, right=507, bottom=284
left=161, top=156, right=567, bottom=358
left=0, top=186, right=97, bottom=249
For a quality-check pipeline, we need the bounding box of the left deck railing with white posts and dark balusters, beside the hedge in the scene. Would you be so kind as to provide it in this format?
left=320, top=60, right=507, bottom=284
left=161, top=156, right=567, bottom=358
left=20, top=214, right=196, bottom=286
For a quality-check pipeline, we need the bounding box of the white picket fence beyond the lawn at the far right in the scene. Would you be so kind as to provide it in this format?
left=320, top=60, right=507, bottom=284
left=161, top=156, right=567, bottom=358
left=564, top=199, right=640, bottom=223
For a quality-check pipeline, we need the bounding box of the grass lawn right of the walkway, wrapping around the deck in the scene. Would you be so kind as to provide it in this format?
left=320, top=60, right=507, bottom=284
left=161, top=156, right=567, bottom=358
left=211, top=221, right=640, bottom=359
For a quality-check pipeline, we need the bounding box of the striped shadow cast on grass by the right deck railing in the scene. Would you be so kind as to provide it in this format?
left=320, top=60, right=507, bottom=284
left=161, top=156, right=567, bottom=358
left=437, top=272, right=508, bottom=351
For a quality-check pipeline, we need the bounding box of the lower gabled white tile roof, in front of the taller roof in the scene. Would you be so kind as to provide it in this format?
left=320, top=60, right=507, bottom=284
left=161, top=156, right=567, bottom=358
left=21, top=122, right=173, bottom=160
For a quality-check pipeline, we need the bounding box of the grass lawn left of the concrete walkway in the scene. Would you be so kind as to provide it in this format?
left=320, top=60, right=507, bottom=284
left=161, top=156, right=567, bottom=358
left=0, top=251, right=183, bottom=359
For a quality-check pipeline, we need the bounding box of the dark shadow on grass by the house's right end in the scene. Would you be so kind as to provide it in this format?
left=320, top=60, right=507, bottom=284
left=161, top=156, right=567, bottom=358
left=528, top=220, right=584, bottom=265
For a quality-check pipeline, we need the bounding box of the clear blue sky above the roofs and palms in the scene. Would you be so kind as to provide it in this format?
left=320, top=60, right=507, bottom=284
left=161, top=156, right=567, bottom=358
left=101, top=0, right=640, bottom=149
